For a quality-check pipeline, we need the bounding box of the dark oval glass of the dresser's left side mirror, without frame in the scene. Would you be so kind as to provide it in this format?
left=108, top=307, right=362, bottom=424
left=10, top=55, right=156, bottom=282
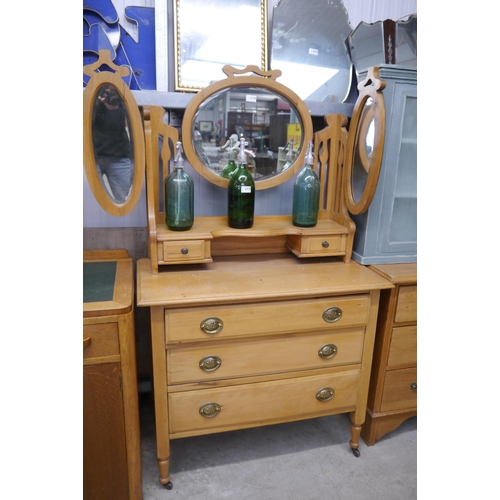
left=92, top=85, right=134, bottom=203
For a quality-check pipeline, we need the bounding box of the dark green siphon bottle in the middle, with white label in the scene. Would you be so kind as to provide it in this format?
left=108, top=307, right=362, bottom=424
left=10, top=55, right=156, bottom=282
left=227, top=138, right=255, bottom=229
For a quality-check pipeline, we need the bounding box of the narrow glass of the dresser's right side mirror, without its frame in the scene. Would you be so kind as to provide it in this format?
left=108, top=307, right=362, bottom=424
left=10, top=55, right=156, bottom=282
left=352, top=97, right=375, bottom=202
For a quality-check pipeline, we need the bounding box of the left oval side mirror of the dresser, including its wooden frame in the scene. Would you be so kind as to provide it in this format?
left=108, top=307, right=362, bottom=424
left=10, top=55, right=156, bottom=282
left=83, top=50, right=145, bottom=216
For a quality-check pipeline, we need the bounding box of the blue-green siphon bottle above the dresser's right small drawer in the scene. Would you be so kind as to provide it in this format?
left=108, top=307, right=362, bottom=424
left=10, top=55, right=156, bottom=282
left=292, top=141, right=320, bottom=227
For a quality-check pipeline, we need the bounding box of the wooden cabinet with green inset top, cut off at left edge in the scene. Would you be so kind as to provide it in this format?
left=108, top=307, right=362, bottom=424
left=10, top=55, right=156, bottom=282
left=83, top=250, right=142, bottom=500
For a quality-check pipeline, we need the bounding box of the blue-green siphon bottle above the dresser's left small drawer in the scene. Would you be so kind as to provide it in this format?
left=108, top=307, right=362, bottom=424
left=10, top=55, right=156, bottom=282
left=165, top=142, right=194, bottom=231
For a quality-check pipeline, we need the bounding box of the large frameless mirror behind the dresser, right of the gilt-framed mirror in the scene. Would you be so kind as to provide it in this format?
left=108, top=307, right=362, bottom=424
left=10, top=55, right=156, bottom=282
left=269, top=0, right=352, bottom=103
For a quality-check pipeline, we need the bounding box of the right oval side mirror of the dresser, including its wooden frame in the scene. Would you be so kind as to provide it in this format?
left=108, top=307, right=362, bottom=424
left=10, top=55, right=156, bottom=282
left=344, top=67, right=385, bottom=215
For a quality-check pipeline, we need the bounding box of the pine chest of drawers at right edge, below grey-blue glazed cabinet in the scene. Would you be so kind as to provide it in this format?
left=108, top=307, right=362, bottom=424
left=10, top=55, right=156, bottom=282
left=361, top=263, right=417, bottom=445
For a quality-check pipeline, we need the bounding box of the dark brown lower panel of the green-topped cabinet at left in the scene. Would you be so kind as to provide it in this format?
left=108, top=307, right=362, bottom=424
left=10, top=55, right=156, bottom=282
left=83, top=363, right=129, bottom=500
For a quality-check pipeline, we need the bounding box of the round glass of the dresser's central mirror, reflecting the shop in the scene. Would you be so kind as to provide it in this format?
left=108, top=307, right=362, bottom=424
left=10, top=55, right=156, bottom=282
left=192, top=86, right=303, bottom=181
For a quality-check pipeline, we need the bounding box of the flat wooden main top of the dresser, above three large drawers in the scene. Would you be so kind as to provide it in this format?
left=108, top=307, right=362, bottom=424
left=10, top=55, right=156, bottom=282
left=137, top=254, right=393, bottom=307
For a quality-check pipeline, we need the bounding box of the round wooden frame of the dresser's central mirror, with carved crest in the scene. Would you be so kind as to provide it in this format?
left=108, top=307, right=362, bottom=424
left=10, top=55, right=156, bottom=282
left=182, top=65, right=313, bottom=191
